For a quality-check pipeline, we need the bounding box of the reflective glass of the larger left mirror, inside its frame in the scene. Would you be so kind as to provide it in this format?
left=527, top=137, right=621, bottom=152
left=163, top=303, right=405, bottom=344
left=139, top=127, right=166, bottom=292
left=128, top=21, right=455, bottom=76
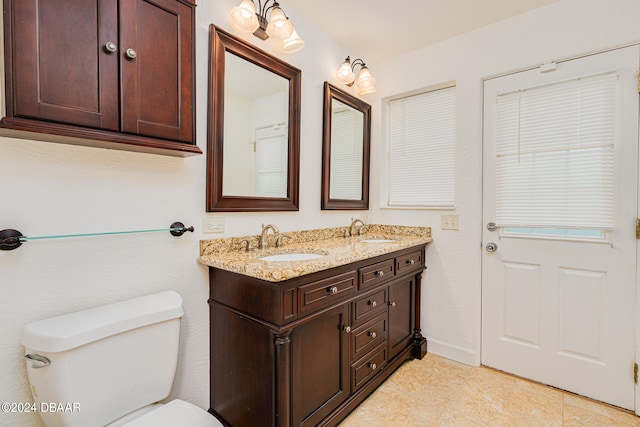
left=222, top=52, right=289, bottom=197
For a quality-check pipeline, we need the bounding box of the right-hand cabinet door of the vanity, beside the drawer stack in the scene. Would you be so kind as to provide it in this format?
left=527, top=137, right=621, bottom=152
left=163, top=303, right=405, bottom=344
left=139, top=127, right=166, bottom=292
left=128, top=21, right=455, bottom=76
left=389, top=277, right=416, bottom=360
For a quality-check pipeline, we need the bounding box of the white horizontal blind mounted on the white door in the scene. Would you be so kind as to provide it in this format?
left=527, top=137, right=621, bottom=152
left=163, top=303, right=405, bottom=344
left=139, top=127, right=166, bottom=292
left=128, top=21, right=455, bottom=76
left=496, top=72, right=617, bottom=230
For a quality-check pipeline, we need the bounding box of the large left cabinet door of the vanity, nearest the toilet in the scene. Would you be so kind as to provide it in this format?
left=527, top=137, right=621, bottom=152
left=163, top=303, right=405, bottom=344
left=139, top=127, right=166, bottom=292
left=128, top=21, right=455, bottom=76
left=291, top=304, right=350, bottom=426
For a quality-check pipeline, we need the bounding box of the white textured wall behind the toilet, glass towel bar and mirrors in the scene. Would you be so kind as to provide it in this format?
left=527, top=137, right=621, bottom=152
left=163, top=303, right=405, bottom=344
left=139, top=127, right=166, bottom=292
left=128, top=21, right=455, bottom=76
left=0, top=0, right=362, bottom=427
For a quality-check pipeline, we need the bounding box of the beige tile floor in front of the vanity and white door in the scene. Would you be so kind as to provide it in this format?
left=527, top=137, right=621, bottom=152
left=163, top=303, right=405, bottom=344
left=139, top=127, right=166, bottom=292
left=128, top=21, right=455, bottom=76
left=339, top=354, right=640, bottom=427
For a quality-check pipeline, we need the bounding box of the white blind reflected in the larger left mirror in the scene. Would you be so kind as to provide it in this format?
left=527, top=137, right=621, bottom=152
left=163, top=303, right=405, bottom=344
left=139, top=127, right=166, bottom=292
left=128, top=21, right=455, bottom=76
left=256, top=125, right=288, bottom=197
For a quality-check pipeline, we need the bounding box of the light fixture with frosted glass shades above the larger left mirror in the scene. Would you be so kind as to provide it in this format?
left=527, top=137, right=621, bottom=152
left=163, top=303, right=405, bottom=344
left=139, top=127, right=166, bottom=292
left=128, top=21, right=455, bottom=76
left=230, top=0, right=304, bottom=53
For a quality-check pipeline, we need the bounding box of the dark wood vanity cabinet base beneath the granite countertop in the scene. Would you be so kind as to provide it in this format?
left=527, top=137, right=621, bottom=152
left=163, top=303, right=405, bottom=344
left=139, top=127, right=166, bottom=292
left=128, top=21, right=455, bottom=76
left=209, top=246, right=426, bottom=427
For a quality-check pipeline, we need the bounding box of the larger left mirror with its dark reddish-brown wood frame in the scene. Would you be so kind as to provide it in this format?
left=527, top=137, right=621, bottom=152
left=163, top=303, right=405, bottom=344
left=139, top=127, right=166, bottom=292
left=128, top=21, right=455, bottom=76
left=207, top=25, right=301, bottom=212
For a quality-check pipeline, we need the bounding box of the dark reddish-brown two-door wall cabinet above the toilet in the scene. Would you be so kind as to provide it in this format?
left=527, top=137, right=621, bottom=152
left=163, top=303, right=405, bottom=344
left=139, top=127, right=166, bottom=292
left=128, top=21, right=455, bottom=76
left=0, top=0, right=201, bottom=156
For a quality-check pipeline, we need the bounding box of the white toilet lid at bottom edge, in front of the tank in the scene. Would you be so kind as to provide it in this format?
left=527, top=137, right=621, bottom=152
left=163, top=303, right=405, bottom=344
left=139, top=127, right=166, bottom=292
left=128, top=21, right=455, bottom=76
left=124, top=399, right=222, bottom=427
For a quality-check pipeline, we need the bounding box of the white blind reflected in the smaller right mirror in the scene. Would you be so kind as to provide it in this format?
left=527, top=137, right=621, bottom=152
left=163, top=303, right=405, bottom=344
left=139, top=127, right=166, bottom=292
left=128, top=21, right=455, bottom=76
left=329, top=105, right=363, bottom=200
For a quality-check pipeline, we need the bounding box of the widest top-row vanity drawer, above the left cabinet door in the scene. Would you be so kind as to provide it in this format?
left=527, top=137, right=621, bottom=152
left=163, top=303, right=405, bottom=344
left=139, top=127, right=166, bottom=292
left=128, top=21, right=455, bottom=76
left=298, top=271, right=358, bottom=313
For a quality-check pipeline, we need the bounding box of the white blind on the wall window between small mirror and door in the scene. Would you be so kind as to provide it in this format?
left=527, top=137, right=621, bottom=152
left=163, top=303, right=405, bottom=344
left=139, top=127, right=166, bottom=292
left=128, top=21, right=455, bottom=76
left=388, top=86, right=456, bottom=207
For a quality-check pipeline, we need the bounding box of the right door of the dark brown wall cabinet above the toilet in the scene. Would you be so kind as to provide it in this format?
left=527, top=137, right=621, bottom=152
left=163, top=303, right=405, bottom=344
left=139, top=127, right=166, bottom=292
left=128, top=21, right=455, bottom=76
left=120, top=0, right=195, bottom=142
